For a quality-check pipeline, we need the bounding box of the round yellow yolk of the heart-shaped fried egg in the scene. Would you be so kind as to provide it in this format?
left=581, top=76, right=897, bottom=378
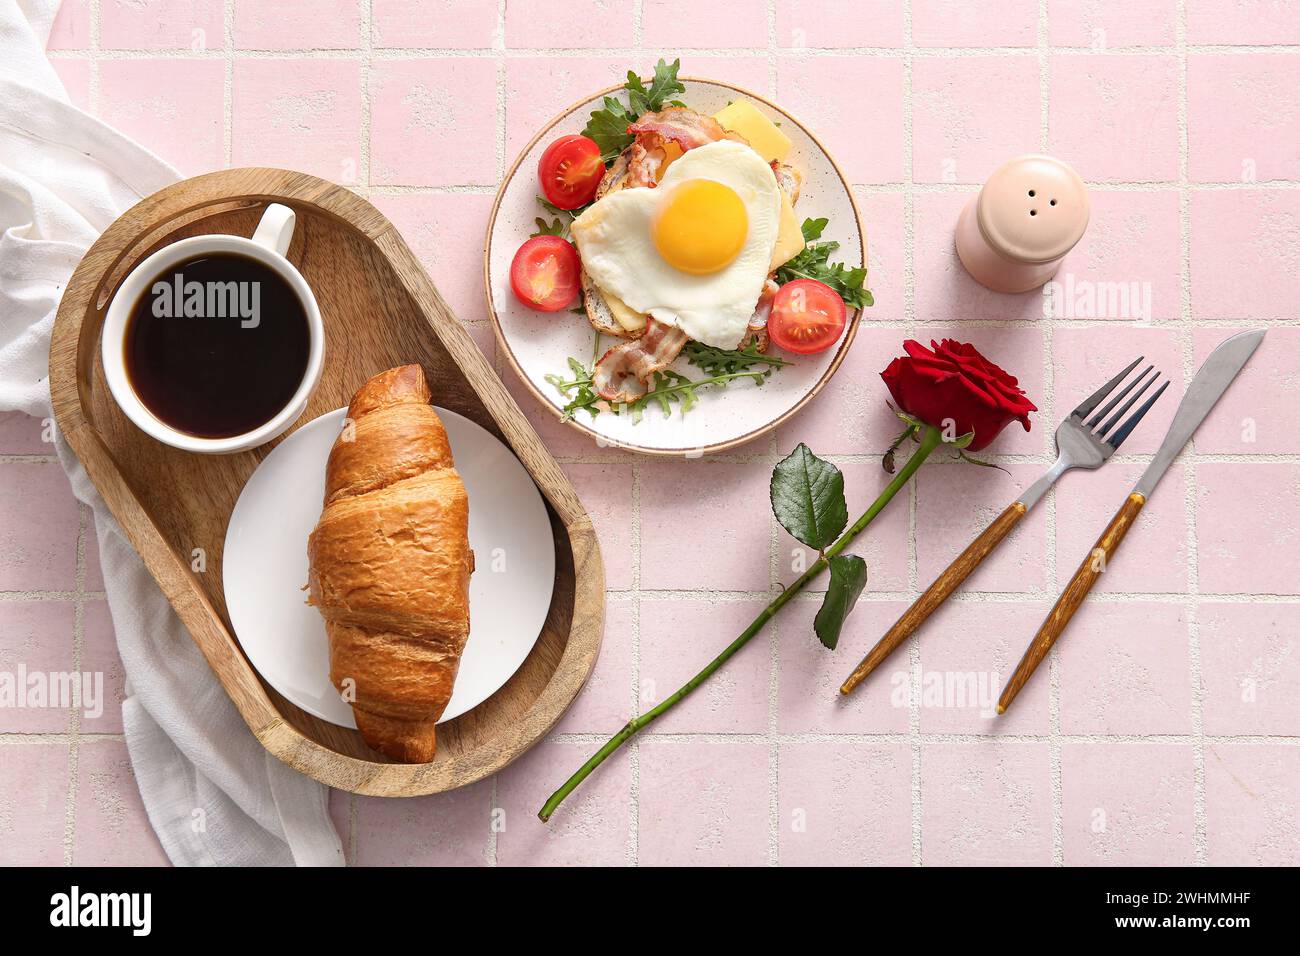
left=653, top=179, right=749, bottom=276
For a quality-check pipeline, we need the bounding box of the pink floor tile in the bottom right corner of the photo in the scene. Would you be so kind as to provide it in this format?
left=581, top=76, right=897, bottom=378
left=1205, top=744, right=1300, bottom=866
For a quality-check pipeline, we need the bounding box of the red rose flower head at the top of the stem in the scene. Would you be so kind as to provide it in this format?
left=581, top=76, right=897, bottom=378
left=880, top=338, right=1037, bottom=451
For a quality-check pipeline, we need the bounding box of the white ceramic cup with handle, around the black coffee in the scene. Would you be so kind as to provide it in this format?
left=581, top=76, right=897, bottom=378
left=100, top=203, right=325, bottom=454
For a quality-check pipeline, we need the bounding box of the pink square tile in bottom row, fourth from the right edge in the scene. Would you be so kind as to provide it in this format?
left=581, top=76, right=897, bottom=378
left=777, top=740, right=911, bottom=866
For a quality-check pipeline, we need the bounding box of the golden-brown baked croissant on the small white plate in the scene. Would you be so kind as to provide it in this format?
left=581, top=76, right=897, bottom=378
left=307, top=365, right=475, bottom=763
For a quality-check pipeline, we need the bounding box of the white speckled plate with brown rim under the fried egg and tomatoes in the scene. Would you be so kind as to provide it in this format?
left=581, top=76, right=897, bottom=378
left=486, top=78, right=866, bottom=455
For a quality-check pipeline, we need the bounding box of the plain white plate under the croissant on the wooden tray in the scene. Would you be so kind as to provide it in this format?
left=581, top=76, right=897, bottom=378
left=221, top=408, right=555, bottom=727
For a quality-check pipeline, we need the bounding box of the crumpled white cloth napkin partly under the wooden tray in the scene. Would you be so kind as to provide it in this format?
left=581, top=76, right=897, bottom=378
left=0, top=0, right=343, bottom=865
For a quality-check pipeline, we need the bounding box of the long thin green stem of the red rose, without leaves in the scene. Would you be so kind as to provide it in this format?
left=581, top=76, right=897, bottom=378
left=537, top=425, right=943, bottom=821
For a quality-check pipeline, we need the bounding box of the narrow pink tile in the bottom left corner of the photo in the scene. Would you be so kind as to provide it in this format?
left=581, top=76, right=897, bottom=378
left=0, top=740, right=69, bottom=866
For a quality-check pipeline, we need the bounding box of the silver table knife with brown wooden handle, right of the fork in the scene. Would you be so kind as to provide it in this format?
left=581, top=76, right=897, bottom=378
left=997, top=329, right=1265, bottom=714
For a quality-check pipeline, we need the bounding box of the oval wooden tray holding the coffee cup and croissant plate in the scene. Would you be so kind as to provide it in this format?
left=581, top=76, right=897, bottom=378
left=49, top=169, right=605, bottom=796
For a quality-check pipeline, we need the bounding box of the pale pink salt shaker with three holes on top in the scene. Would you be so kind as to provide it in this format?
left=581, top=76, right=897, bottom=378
left=957, top=155, right=1088, bottom=293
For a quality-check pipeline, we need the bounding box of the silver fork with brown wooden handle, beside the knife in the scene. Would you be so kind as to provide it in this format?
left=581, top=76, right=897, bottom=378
left=840, top=355, right=1169, bottom=693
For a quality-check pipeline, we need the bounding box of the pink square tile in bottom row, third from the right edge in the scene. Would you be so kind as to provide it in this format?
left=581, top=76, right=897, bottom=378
left=920, top=743, right=1052, bottom=866
